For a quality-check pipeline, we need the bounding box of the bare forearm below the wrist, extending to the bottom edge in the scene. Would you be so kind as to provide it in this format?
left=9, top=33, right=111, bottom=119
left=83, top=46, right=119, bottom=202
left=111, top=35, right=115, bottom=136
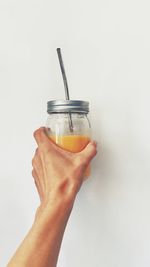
left=7, top=195, right=74, bottom=267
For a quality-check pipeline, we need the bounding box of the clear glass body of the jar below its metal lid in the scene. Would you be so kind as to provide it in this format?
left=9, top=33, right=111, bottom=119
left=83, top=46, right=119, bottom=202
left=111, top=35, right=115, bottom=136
left=46, top=113, right=91, bottom=177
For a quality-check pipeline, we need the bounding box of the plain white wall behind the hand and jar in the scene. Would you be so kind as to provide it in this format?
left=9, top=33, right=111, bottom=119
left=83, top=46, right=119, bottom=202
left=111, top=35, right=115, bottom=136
left=0, top=0, right=150, bottom=267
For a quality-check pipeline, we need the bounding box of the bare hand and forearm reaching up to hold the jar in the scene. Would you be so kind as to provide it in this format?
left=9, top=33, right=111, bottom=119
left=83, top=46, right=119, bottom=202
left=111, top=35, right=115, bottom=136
left=7, top=127, right=97, bottom=267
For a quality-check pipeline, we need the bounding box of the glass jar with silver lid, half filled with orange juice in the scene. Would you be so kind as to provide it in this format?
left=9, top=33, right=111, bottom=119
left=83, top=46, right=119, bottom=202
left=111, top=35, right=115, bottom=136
left=46, top=100, right=91, bottom=177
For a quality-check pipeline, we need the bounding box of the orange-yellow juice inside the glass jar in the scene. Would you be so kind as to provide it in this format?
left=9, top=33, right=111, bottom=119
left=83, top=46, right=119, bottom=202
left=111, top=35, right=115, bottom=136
left=49, top=135, right=91, bottom=177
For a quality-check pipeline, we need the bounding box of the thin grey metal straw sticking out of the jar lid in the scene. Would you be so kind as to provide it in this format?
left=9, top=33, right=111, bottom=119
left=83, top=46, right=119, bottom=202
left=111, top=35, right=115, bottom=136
left=57, top=48, right=73, bottom=132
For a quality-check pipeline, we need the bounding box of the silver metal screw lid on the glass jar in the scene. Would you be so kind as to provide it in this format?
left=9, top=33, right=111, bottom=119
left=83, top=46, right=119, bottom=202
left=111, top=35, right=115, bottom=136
left=47, top=100, right=89, bottom=114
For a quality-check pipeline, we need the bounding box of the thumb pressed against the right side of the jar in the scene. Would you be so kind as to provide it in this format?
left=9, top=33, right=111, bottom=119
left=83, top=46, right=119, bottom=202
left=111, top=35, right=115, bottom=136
left=79, top=141, right=97, bottom=164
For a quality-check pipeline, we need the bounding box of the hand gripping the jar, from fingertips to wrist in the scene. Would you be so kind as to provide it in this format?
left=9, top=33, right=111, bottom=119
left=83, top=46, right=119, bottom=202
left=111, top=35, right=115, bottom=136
left=32, top=127, right=97, bottom=209
